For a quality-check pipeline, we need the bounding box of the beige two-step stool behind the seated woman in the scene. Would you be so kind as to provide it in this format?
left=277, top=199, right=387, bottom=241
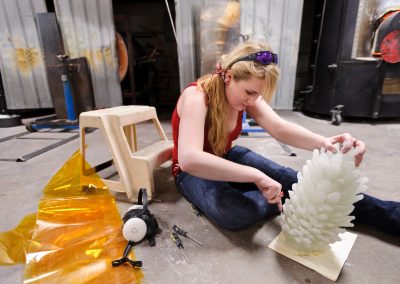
left=80, top=106, right=173, bottom=202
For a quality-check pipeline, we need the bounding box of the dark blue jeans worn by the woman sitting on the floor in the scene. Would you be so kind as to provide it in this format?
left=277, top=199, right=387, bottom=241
left=175, top=146, right=400, bottom=235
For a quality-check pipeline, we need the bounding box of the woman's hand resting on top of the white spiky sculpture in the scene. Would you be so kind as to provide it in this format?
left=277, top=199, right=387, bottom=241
left=323, top=133, right=367, bottom=167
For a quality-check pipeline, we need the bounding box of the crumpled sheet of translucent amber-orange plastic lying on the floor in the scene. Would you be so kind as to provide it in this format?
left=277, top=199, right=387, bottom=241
left=0, top=152, right=143, bottom=283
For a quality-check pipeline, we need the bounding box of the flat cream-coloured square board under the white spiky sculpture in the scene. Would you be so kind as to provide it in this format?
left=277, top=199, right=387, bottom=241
left=268, top=232, right=357, bottom=281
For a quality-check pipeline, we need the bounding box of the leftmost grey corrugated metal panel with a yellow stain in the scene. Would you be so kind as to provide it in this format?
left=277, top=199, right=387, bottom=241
left=0, top=0, right=53, bottom=110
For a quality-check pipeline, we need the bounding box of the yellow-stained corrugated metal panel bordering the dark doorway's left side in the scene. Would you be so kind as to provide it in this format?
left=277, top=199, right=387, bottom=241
left=54, top=0, right=122, bottom=108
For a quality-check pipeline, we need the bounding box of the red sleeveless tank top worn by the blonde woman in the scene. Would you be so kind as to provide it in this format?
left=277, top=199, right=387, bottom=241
left=172, top=82, right=243, bottom=177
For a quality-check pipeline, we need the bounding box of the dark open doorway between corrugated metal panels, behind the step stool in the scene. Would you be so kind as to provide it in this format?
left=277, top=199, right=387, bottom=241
left=113, top=0, right=180, bottom=107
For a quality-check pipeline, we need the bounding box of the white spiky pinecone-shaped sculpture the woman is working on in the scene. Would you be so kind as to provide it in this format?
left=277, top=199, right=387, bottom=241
left=282, top=144, right=368, bottom=254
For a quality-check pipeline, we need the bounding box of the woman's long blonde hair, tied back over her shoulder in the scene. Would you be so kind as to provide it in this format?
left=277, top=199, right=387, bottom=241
left=197, top=40, right=279, bottom=156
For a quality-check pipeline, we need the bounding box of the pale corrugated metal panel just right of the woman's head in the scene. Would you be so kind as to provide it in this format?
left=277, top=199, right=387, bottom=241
left=240, top=0, right=303, bottom=109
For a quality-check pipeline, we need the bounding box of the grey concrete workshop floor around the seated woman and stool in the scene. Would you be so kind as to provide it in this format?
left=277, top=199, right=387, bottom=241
left=0, top=111, right=400, bottom=284
